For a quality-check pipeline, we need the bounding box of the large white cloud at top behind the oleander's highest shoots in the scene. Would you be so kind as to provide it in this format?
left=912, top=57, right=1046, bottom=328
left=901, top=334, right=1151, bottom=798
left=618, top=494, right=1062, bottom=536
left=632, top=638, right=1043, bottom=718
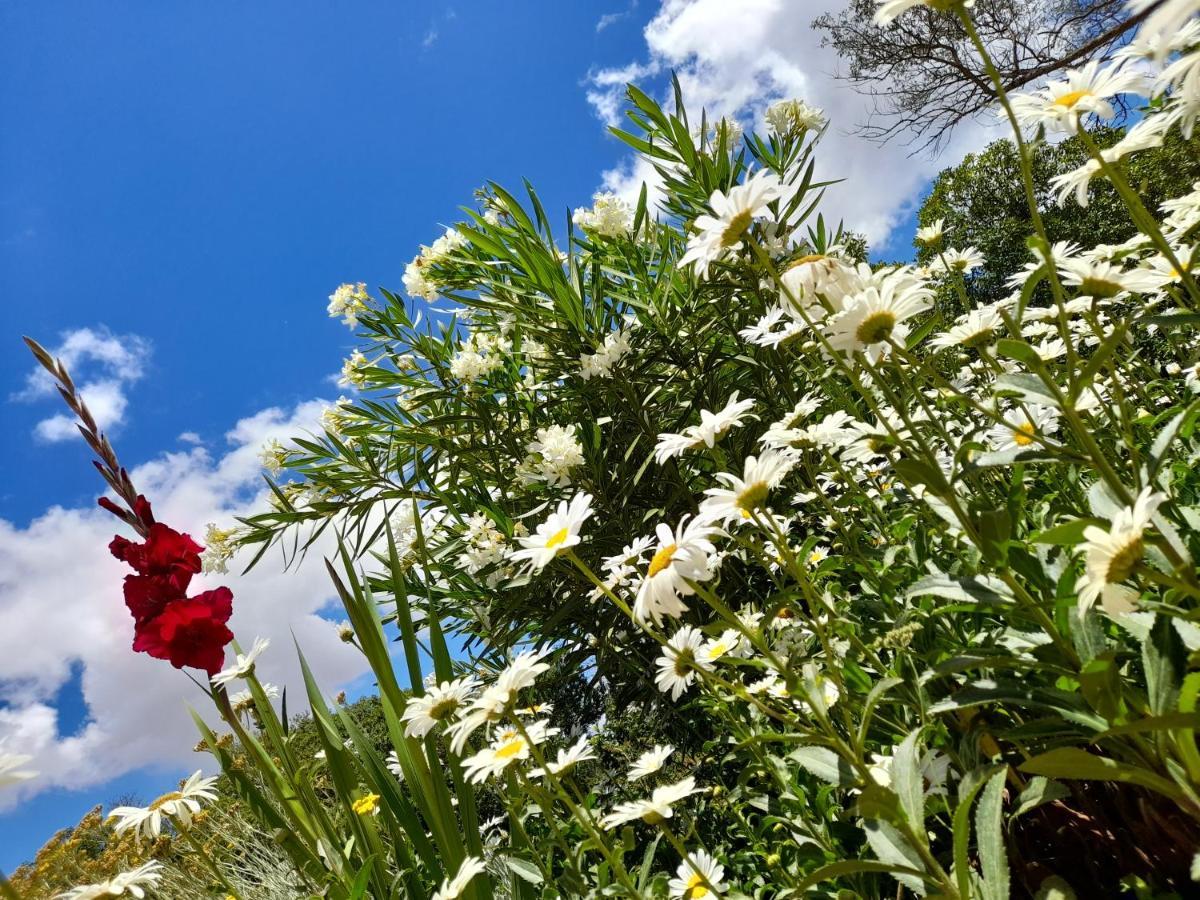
left=588, top=0, right=995, bottom=245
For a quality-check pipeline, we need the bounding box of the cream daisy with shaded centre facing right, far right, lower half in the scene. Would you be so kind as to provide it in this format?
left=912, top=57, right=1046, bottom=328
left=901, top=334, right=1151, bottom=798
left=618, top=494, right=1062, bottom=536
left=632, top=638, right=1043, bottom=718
left=1075, top=487, right=1166, bottom=616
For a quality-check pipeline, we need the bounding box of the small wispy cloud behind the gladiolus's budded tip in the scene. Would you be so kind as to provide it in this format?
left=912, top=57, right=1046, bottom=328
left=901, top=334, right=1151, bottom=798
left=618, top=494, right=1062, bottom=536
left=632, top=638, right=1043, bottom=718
left=12, top=328, right=150, bottom=442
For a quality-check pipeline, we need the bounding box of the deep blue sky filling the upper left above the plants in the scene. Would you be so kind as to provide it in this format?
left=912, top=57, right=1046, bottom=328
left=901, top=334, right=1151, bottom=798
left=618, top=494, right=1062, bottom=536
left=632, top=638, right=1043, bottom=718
left=0, top=0, right=936, bottom=870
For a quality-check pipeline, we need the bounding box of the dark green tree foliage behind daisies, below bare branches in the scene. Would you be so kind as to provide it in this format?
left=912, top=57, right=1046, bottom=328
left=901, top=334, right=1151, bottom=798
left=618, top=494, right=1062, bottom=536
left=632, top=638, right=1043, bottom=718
left=917, top=128, right=1200, bottom=304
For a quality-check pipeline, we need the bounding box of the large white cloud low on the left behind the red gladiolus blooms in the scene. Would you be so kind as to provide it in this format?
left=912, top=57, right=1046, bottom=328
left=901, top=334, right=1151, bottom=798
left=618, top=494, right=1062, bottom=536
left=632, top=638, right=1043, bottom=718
left=0, top=401, right=365, bottom=804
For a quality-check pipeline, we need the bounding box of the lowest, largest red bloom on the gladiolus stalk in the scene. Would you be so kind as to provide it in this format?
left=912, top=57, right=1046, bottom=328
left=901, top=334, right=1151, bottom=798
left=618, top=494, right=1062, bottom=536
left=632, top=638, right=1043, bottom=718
left=133, top=588, right=233, bottom=676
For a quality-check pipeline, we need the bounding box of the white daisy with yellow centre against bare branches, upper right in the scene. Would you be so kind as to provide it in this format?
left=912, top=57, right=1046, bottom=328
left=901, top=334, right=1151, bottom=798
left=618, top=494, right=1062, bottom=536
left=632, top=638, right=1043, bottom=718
left=1012, top=60, right=1150, bottom=134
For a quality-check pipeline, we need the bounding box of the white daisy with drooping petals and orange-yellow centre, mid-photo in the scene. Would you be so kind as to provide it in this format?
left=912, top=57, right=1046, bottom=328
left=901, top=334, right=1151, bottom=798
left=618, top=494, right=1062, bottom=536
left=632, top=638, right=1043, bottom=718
left=632, top=517, right=716, bottom=625
